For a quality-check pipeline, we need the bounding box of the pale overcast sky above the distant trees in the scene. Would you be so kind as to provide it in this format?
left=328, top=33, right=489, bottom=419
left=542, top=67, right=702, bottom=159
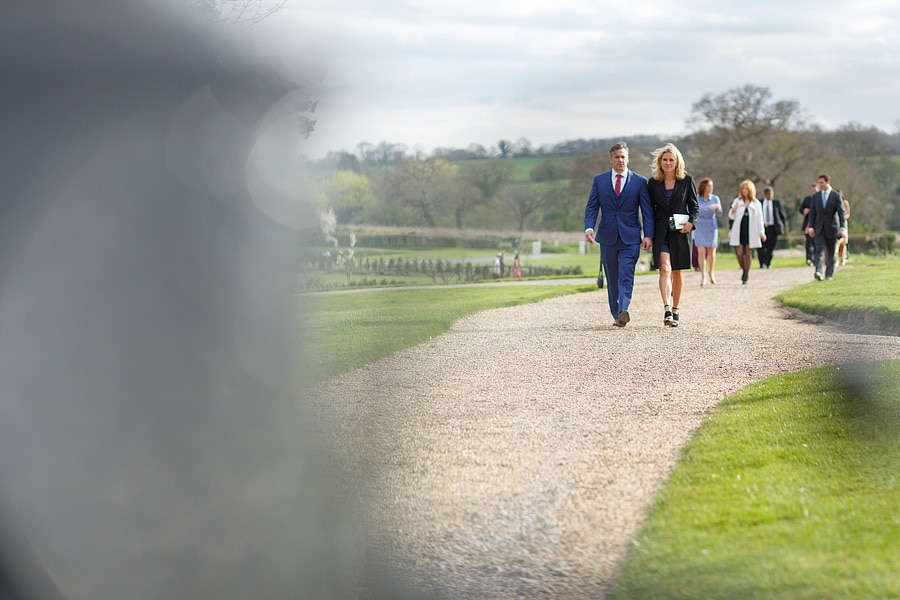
left=256, top=0, right=900, bottom=158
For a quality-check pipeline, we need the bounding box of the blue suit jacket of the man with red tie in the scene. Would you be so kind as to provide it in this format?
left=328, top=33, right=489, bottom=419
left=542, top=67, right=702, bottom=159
left=584, top=171, right=654, bottom=246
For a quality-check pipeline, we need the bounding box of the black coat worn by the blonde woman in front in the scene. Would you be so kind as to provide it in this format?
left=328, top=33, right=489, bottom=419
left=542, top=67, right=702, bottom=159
left=647, top=175, right=700, bottom=271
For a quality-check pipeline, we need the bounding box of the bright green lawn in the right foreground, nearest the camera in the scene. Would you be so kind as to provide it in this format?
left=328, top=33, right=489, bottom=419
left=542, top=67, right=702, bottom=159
left=613, top=362, right=900, bottom=600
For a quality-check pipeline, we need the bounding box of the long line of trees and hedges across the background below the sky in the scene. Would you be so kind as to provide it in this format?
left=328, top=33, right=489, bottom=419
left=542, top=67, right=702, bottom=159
left=311, top=85, right=900, bottom=233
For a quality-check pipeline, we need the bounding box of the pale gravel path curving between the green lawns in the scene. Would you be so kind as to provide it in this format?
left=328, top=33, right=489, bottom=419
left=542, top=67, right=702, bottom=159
left=314, top=268, right=900, bottom=598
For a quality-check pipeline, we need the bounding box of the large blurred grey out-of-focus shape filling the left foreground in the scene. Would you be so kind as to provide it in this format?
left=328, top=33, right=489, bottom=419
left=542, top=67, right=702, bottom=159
left=0, top=1, right=343, bottom=600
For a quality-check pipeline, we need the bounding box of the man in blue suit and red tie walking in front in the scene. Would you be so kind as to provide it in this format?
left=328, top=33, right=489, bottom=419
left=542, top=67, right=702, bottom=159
left=584, top=142, right=653, bottom=327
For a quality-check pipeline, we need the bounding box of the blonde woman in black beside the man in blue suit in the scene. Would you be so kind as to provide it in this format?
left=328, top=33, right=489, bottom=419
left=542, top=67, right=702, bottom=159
left=647, top=143, right=700, bottom=327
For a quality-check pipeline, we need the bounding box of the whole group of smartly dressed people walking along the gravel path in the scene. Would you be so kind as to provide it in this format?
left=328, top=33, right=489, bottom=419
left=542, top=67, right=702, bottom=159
left=584, top=142, right=846, bottom=328
